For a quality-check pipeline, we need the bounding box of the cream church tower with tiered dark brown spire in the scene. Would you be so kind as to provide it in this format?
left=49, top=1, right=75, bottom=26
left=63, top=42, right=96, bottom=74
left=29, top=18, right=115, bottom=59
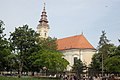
left=37, top=3, right=50, bottom=38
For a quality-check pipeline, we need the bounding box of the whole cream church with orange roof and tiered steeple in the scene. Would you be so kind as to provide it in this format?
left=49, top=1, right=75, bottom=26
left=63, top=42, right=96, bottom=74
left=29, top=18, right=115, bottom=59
left=37, top=4, right=96, bottom=71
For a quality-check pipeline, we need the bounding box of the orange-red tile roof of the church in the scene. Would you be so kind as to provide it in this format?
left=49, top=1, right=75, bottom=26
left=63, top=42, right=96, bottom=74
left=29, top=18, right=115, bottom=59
left=57, top=34, right=95, bottom=50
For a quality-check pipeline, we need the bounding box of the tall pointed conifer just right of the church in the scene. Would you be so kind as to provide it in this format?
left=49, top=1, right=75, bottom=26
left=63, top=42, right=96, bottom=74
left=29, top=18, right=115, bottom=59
left=91, top=31, right=111, bottom=73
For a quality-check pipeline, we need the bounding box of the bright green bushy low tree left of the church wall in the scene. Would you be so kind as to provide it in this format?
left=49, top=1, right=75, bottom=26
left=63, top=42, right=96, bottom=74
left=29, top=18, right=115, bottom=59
left=34, top=50, right=68, bottom=72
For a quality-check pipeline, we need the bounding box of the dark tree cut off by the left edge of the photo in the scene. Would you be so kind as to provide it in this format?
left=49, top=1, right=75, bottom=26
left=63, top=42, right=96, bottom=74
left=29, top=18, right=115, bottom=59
left=0, top=20, right=11, bottom=70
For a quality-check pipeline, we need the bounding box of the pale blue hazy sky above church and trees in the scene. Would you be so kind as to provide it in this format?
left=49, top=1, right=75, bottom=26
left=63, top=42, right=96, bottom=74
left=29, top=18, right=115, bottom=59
left=0, top=0, right=120, bottom=48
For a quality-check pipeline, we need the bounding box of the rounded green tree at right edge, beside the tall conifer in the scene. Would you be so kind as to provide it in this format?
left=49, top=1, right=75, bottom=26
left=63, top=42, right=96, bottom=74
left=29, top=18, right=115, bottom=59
left=105, top=46, right=120, bottom=73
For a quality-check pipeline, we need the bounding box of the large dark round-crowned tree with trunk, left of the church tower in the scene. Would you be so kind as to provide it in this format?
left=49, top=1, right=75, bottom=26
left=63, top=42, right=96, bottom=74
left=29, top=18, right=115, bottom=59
left=10, top=25, right=37, bottom=77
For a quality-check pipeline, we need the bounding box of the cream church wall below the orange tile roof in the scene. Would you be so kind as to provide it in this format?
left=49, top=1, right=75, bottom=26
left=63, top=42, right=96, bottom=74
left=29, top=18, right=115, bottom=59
left=62, top=49, right=95, bottom=71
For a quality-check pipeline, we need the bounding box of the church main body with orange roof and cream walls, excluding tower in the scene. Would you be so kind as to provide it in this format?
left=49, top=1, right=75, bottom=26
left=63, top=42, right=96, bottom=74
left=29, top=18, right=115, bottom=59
left=57, top=34, right=96, bottom=71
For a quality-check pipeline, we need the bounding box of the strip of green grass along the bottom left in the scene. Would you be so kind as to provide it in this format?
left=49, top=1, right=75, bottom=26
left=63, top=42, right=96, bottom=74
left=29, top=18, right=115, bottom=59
left=0, top=76, right=59, bottom=80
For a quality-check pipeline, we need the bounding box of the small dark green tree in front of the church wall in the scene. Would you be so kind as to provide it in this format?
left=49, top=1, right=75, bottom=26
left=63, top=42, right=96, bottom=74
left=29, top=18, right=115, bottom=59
left=72, top=59, right=86, bottom=79
